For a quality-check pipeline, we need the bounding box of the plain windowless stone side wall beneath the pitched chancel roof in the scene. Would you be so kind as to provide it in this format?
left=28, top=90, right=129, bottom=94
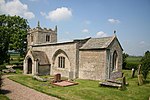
left=79, top=50, right=106, bottom=80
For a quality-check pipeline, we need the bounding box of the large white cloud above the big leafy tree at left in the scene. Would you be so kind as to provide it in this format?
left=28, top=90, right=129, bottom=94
left=0, top=0, right=35, bottom=19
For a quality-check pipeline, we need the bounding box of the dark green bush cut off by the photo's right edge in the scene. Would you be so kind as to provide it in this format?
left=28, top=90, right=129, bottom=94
left=141, top=51, right=150, bottom=80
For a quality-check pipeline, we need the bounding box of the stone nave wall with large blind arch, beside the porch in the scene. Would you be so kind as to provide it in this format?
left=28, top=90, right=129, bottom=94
left=32, top=42, right=78, bottom=78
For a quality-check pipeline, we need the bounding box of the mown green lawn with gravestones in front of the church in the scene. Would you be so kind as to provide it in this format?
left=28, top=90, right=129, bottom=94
left=9, top=70, right=150, bottom=100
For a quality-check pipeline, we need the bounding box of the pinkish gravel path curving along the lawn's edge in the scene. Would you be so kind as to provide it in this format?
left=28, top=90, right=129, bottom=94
left=2, top=76, right=58, bottom=100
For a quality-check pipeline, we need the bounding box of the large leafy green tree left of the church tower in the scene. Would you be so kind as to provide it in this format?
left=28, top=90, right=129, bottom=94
left=0, top=15, right=29, bottom=63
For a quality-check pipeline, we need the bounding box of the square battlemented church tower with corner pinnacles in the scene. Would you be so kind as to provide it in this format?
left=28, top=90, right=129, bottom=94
left=27, top=21, right=57, bottom=46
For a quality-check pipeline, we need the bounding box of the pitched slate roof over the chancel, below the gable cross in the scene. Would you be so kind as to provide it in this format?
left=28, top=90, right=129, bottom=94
left=80, top=36, right=115, bottom=49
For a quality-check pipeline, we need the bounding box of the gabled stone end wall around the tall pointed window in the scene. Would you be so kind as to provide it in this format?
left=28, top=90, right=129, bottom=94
left=106, top=38, right=123, bottom=79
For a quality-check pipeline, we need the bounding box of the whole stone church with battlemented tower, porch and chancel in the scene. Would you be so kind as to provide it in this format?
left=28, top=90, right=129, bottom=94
left=24, top=23, right=123, bottom=80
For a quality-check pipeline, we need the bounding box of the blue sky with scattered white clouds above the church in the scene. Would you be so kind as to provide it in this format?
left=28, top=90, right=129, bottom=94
left=0, top=0, right=150, bottom=56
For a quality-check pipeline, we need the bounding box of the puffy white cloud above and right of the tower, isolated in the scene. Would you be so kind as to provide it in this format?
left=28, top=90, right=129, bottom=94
left=46, top=7, right=72, bottom=21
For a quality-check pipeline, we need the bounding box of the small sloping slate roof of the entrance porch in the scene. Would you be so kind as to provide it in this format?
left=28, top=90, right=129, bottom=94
left=31, top=51, right=50, bottom=65
